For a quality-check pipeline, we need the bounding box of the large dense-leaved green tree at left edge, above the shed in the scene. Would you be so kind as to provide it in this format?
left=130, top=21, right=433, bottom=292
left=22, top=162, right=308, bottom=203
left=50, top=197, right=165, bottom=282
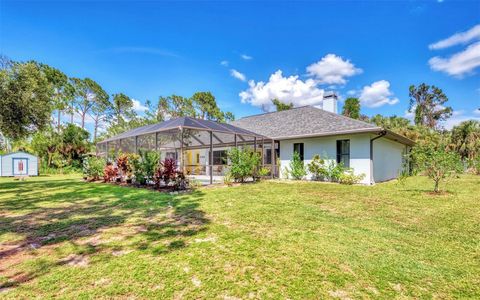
left=0, top=62, right=53, bottom=140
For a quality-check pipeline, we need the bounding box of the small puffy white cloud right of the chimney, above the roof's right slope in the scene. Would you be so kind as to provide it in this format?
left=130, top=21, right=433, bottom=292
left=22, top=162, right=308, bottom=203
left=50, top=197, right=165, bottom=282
left=359, top=80, right=399, bottom=107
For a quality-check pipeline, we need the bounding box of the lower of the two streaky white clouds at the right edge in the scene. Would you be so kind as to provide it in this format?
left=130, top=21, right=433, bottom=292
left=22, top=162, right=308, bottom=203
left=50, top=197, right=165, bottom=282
left=428, top=42, right=480, bottom=77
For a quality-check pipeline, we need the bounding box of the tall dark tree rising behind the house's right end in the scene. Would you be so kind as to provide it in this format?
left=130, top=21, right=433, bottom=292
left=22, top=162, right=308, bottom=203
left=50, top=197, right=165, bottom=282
left=408, top=83, right=452, bottom=129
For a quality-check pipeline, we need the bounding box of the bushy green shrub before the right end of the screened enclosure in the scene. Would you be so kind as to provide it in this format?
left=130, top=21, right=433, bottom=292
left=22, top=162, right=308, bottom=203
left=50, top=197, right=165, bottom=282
left=228, top=148, right=260, bottom=182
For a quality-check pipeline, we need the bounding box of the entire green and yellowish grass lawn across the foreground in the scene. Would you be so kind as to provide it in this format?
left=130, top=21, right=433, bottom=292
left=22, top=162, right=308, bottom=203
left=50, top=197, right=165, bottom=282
left=0, top=175, right=480, bottom=299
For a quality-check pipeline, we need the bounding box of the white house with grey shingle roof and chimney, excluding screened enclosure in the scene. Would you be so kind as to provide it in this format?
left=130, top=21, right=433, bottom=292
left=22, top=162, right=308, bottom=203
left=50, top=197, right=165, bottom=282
left=232, top=94, right=414, bottom=184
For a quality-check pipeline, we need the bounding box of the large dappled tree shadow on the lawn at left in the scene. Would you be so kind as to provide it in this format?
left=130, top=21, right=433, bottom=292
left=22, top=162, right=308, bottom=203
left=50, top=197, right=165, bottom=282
left=0, top=179, right=209, bottom=290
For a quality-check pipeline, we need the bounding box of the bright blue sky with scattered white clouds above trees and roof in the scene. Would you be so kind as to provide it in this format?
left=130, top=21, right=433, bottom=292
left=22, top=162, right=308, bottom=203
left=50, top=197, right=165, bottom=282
left=0, top=0, right=480, bottom=134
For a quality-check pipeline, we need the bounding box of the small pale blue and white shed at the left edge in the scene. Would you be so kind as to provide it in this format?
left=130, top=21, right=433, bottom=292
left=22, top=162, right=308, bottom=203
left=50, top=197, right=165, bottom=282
left=0, top=152, right=38, bottom=177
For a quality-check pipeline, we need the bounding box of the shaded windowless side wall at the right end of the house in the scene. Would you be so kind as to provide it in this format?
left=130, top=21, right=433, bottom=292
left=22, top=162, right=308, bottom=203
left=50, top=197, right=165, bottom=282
left=373, top=138, right=407, bottom=182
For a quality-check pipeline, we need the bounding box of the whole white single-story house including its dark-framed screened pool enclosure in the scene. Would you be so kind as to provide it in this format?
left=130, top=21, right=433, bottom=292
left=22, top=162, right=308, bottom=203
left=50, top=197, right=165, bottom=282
left=97, top=94, right=414, bottom=184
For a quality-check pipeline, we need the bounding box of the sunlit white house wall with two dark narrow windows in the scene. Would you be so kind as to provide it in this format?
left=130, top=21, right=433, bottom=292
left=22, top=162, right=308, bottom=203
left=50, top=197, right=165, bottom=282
left=279, top=134, right=372, bottom=184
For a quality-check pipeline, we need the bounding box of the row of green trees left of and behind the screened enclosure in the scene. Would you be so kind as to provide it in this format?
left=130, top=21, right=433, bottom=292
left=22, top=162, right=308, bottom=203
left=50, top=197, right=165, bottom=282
left=0, top=55, right=235, bottom=171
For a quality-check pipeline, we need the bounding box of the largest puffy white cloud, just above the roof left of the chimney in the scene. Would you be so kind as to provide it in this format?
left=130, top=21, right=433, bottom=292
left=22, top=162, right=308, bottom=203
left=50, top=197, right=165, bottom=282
left=239, top=70, right=324, bottom=111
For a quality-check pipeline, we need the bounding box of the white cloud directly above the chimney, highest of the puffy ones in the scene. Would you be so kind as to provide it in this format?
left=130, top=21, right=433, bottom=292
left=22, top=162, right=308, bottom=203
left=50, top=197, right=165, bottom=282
left=307, top=54, right=362, bottom=84
